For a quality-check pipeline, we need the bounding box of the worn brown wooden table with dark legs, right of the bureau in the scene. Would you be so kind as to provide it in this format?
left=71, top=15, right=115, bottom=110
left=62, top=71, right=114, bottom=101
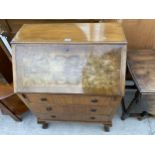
left=121, top=50, right=155, bottom=120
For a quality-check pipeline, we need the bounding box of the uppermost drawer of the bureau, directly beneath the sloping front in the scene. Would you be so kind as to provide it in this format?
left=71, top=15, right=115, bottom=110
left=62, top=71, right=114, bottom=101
left=24, top=94, right=121, bottom=106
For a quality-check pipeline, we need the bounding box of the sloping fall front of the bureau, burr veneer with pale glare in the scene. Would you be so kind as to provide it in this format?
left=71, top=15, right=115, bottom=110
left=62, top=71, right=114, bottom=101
left=13, top=44, right=126, bottom=95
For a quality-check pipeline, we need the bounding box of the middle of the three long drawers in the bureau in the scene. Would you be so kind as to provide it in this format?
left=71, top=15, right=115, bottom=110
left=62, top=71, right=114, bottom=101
left=25, top=103, right=114, bottom=115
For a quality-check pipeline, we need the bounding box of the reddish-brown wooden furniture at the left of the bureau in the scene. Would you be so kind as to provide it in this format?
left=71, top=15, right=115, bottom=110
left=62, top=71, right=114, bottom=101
left=0, top=33, right=28, bottom=121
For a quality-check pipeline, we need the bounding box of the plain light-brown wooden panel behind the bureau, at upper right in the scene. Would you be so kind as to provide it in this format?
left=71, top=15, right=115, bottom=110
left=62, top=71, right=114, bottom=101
left=122, top=19, right=155, bottom=49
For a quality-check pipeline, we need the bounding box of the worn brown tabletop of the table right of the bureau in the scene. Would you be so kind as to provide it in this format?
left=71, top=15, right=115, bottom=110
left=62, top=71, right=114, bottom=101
left=128, top=50, right=155, bottom=93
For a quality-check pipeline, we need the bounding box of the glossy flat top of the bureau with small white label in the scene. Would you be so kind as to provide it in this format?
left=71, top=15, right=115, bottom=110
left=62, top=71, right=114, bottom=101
left=12, top=23, right=126, bottom=44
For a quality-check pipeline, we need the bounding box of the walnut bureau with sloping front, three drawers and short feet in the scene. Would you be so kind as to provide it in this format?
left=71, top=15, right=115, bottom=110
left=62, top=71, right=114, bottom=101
left=12, top=23, right=127, bottom=131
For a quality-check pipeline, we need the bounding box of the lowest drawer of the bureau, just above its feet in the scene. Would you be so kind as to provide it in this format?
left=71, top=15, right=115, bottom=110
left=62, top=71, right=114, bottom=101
left=36, top=114, right=112, bottom=122
